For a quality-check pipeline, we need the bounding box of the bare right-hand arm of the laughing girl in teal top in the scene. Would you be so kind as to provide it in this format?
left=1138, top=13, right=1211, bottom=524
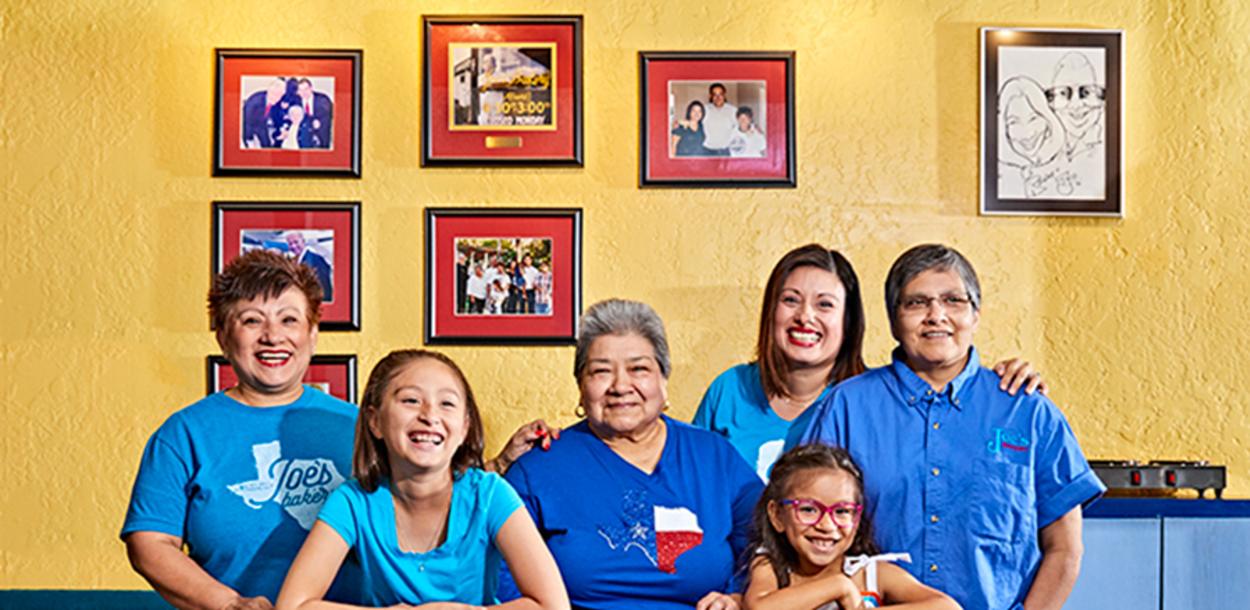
left=494, top=506, right=569, bottom=610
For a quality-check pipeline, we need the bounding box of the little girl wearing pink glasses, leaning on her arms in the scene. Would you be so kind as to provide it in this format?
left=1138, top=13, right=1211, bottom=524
left=744, top=445, right=959, bottom=610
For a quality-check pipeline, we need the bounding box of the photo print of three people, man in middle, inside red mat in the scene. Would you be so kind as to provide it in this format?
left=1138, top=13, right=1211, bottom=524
left=669, top=80, right=768, bottom=158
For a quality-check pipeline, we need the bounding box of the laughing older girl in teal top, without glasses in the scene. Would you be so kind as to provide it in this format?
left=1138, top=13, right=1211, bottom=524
left=278, top=350, right=569, bottom=610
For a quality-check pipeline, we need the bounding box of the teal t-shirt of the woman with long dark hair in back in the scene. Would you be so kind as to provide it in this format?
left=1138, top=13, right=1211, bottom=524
left=691, top=363, right=830, bottom=481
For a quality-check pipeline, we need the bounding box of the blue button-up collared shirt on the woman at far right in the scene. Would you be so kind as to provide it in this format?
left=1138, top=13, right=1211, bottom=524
left=801, top=349, right=1106, bottom=610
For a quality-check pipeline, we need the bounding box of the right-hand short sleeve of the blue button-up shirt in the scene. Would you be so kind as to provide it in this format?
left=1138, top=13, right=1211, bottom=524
left=1034, top=399, right=1106, bottom=529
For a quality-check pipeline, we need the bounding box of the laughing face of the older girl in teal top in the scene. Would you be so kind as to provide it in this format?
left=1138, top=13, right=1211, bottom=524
left=369, top=358, right=470, bottom=479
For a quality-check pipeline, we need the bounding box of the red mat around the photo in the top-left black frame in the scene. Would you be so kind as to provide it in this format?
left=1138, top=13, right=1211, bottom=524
left=218, top=58, right=359, bottom=170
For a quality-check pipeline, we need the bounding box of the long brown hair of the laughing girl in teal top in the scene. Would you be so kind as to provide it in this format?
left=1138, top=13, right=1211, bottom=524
left=351, top=350, right=485, bottom=491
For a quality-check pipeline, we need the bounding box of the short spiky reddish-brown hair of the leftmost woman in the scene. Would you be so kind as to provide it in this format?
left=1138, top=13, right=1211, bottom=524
left=209, top=250, right=324, bottom=330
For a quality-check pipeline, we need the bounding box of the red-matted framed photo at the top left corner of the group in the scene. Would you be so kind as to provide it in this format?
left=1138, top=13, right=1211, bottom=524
left=213, top=49, right=361, bottom=178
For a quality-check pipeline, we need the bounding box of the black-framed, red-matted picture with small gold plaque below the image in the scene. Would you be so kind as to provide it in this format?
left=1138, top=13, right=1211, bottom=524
left=421, top=15, right=583, bottom=166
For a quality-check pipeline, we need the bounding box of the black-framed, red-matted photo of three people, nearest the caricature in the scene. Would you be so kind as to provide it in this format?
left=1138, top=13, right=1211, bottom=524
left=639, top=51, right=798, bottom=188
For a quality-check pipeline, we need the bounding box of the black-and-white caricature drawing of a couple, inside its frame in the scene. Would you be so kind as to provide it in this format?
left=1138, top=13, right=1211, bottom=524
left=998, top=46, right=1106, bottom=200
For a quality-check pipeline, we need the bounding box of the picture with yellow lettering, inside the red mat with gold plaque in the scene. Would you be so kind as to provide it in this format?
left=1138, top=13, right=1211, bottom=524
left=450, top=44, right=555, bottom=129
